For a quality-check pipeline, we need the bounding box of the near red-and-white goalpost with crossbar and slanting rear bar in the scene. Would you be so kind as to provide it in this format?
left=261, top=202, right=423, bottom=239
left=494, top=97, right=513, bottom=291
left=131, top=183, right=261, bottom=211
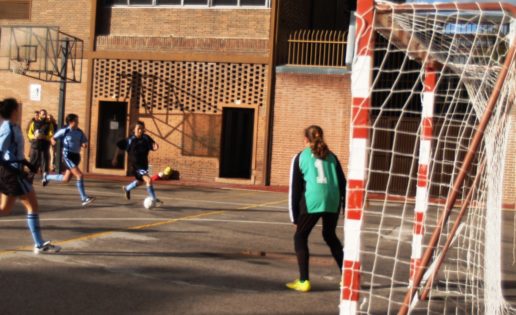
left=340, top=0, right=516, bottom=315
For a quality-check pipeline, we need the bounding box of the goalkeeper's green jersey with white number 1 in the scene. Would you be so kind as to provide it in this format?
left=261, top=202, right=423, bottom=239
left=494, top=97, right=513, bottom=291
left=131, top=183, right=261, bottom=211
left=299, top=148, right=340, bottom=213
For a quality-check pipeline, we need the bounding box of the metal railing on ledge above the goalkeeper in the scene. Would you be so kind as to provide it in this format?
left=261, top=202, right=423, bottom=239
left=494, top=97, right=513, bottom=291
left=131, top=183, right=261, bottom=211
left=288, top=30, right=347, bottom=67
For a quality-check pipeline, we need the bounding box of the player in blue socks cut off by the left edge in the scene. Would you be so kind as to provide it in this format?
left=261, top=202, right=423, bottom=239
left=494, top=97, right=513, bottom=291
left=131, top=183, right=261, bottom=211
left=0, top=98, right=61, bottom=254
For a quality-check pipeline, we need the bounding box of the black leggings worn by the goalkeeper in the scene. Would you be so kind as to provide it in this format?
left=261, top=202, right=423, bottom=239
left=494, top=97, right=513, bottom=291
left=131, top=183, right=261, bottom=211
left=294, top=211, right=343, bottom=281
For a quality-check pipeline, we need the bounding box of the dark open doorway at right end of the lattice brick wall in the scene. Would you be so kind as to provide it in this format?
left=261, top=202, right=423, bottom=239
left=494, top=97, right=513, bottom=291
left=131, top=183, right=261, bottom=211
left=220, top=108, right=254, bottom=179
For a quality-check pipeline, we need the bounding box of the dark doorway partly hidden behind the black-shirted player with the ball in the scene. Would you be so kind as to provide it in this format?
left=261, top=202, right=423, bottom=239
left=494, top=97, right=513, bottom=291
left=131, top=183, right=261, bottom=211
left=96, top=101, right=127, bottom=169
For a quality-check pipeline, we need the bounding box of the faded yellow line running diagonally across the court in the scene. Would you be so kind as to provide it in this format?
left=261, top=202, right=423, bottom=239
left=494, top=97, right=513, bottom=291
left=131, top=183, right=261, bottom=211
left=0, top=200, right=286, bottom=256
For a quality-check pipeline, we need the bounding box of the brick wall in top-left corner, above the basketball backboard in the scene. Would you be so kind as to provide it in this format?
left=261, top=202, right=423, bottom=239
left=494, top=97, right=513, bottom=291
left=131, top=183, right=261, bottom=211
left=0, top=0, right=91, bottom=50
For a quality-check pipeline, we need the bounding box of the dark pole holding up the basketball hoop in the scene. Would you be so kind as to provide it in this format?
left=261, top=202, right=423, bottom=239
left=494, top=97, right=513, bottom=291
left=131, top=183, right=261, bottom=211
left=56, top=38, right=70, bottom=174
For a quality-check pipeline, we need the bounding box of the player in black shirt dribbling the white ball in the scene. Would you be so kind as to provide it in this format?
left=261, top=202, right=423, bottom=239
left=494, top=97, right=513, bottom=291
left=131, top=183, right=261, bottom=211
left=112, top=121, right=163, bottom=206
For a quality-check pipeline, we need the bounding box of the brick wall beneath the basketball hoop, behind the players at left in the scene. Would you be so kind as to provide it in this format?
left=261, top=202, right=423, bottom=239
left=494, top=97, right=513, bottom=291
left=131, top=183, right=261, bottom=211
left=0, top=60, right=88, bottom=160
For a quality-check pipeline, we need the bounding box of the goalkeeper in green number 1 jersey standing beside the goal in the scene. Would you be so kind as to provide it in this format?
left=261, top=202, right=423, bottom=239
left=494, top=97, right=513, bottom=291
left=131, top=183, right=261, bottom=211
left=287, top=126, right=346, bottom=292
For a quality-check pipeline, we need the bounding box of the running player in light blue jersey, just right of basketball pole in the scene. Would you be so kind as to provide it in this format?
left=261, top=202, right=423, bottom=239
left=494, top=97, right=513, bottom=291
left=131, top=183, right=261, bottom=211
left=42, top=114, right=95, bottom=206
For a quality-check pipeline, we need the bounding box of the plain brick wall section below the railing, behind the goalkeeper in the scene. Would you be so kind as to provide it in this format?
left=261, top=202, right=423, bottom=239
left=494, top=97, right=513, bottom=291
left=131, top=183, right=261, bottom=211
left=271, top=73, right=351, bottom=185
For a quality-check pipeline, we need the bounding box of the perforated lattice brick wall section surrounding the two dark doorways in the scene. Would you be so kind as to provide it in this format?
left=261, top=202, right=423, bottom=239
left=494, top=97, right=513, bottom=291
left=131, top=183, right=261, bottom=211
left=89, top=60, right=267, bottom=184
